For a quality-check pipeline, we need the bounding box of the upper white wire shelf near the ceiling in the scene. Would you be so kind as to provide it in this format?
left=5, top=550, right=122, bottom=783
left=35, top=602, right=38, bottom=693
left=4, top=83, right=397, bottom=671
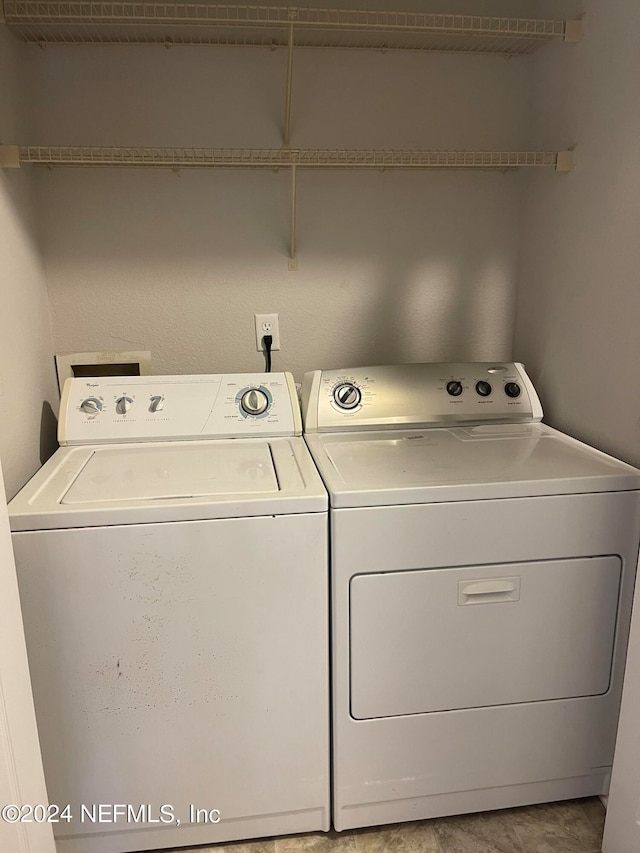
left=4, top=0, right=582, bottom=55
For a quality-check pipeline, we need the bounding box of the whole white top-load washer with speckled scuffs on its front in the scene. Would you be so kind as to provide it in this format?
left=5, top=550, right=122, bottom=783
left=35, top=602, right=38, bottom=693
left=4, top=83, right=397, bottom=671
left=9, top=373, right=329, bottom=853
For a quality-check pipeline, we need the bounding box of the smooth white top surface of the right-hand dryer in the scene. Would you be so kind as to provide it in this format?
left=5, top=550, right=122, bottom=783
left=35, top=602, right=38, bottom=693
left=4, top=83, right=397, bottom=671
left=306, top=424, right=640, bottom=507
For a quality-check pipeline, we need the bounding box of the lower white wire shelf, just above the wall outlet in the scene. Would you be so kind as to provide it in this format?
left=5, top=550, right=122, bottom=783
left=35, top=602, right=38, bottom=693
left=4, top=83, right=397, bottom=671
left=0, top=145, right=573, bottom=172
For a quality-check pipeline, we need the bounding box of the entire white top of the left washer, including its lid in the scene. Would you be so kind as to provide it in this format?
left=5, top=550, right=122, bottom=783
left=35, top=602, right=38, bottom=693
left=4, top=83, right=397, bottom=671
left=9, top=437, right=328, bottom=531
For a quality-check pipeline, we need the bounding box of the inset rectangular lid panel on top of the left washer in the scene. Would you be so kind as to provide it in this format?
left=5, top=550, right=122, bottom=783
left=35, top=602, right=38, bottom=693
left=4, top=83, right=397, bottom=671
left=61, top=441, right=279, bottom=505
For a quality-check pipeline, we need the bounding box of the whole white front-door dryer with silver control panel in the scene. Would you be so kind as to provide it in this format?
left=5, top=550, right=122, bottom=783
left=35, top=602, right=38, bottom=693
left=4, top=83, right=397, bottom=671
left=303, top=363, right=640, bottom=830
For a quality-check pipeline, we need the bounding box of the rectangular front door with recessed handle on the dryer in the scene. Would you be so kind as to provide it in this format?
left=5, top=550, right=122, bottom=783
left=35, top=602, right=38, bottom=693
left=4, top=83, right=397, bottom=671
left=350, top=556, right=621, bottom=719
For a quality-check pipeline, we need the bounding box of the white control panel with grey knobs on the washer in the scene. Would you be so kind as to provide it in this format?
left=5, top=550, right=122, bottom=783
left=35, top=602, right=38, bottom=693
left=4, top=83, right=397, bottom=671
left=58, top=373, right=301, bottom=445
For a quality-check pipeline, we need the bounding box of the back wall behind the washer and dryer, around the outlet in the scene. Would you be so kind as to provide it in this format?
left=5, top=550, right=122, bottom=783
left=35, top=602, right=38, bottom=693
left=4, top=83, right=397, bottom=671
left=30, top=36, right=536, bottom=377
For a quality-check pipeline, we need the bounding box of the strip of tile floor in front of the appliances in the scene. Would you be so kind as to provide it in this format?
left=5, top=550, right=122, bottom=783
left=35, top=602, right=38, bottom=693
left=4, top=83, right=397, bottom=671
left=160, top=798, right=605, bottom=853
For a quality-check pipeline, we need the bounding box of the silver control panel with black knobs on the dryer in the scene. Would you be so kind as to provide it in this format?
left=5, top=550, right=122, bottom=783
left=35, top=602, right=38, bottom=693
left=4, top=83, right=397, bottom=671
left=302, top=362, right=542, bottom=432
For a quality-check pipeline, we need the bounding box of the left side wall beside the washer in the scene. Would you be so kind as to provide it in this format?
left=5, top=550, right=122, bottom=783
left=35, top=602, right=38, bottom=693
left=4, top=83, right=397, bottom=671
left=0, top=28, right=57, bottom=497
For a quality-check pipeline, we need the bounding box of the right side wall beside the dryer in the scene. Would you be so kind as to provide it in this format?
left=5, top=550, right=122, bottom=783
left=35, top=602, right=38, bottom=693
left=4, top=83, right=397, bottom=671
left=515, top=0, right=640, bottom=465
